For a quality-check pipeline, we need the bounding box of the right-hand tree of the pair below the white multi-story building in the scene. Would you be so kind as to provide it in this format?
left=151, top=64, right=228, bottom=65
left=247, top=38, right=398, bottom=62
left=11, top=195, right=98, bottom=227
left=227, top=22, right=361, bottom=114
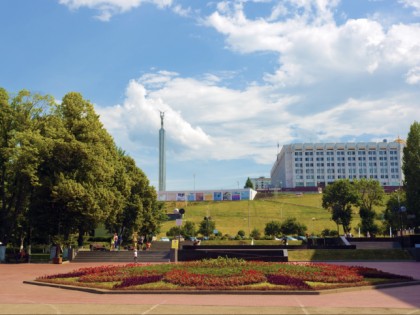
left=353, top=178, right=385, bottom=235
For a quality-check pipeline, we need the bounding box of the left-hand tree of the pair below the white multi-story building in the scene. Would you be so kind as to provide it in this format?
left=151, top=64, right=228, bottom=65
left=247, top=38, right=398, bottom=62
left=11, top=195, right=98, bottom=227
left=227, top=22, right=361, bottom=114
left=322, top=179, right=357, bottom=233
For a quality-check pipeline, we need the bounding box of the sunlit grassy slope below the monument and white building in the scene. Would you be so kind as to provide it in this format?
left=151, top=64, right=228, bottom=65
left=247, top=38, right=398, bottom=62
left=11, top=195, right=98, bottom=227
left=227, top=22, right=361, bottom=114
left=159, top=194, right=366, bottom=236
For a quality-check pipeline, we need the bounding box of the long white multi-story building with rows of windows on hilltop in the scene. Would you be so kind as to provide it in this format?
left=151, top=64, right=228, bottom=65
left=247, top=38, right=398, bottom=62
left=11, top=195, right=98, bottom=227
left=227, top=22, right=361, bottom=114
left=271, top=139, right=405, bottom=188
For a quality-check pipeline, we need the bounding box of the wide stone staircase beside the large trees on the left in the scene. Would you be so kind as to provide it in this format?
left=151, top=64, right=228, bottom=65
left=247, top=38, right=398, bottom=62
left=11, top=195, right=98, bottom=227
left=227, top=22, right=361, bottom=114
left=71, top=242, right=170, bottom=263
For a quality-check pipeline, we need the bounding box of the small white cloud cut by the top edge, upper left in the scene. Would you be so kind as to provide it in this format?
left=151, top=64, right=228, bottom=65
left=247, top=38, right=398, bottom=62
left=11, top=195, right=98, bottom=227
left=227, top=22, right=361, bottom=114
left=59, top=0, right=173, bottom=22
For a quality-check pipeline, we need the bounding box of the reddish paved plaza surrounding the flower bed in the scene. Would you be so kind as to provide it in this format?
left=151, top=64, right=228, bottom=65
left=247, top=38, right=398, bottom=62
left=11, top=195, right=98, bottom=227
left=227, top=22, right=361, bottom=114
left=0, top=262, right=420, bottom=315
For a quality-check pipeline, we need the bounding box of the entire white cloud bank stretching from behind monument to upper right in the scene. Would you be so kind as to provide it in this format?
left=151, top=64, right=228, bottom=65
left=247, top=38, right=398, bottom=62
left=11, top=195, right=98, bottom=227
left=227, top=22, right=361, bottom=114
left=100, top=0, right=420, bottom=173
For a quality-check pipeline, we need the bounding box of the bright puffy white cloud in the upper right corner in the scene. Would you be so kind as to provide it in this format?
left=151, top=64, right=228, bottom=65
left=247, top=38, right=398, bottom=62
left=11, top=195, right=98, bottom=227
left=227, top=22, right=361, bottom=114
left=206, top=0, right=420, bottom=88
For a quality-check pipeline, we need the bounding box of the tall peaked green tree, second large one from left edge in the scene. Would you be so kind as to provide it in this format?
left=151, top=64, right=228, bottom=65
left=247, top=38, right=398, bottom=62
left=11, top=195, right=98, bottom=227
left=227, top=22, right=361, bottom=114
left=28, top=93, right=122, bottom=245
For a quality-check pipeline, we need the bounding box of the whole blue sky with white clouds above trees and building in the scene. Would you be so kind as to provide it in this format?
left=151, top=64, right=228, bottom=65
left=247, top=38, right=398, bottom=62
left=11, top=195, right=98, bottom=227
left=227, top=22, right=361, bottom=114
left=0, top=0, right=420, bottom=190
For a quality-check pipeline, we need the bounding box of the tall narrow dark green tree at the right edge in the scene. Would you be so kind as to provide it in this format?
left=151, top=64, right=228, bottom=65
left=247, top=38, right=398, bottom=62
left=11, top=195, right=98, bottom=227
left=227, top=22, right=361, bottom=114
left=402, top=122, right=420, bottom=226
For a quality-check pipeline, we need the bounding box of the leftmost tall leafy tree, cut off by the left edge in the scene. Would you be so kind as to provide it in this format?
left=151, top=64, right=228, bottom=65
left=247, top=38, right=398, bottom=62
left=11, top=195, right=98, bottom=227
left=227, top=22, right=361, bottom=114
left=0, top=89, right=53, bottom=246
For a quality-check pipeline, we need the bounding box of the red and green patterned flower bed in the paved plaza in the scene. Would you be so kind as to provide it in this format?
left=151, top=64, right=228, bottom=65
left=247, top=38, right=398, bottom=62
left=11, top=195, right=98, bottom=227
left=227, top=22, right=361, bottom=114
left=36, top=258, right=413, bottom=291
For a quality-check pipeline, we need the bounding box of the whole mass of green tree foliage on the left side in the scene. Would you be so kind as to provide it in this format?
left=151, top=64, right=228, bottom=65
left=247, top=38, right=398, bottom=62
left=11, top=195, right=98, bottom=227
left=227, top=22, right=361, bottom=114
left=0, top=89, right=163, bottom=248
